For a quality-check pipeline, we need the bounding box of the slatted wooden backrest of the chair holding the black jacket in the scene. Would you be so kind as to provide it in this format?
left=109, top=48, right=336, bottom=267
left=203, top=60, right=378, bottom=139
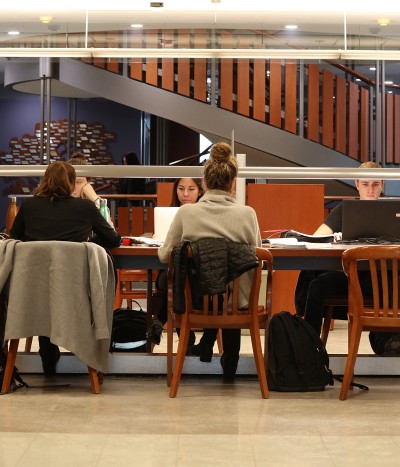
left=168, top=247, right=273, bottom=324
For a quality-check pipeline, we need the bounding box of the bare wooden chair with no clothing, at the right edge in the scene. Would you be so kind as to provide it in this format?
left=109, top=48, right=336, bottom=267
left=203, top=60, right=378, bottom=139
left=339, top=246, right=400, bottom=400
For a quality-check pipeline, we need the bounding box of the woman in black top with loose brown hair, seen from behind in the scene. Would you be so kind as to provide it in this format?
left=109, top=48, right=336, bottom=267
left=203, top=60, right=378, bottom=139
left=10, top=162, right=121, bottom=376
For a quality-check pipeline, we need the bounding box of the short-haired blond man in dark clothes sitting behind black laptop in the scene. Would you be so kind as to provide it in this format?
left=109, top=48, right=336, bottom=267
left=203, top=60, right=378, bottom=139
left=295, top=162, right=394, bottom=353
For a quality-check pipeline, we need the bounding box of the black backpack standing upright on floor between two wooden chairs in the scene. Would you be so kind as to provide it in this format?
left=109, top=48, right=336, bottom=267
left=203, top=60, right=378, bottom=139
left=268, top=311, right=333, bottom=392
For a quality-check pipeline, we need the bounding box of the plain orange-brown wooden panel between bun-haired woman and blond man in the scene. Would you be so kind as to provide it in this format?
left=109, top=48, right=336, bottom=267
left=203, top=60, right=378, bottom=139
left=246, top=184, right=324, bottom=313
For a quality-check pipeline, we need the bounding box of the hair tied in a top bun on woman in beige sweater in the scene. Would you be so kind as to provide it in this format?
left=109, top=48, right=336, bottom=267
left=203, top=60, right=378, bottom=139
left=203, top=143, right=238, bottom=191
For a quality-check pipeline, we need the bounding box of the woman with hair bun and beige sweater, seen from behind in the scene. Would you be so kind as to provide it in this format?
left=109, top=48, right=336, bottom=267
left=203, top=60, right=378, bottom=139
left=158, top=143, right=261, bottom=378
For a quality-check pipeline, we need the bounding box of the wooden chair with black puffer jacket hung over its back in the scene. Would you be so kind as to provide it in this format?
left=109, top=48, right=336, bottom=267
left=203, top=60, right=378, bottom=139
left=167, top=248, right=272, bottom=398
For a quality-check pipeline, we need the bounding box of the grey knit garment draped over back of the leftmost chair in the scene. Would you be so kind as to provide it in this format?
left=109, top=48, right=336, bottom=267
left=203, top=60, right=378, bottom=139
left=0, top=240, right=115, bottom=371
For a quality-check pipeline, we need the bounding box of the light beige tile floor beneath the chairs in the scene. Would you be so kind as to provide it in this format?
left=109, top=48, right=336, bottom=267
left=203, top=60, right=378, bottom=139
left=0, top=324, right=400, bottom=467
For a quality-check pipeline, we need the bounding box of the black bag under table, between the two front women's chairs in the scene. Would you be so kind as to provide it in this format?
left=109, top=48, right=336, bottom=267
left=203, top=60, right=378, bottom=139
left=110, top=302, right=147, bottom=352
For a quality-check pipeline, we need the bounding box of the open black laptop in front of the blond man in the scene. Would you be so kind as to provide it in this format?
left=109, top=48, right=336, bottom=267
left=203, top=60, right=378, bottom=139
left=342, top=199, right=400, bottom=243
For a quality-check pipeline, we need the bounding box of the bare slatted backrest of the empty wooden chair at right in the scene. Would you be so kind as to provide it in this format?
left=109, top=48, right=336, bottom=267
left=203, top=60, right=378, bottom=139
left=342, top=246, right=400, bottom=326
